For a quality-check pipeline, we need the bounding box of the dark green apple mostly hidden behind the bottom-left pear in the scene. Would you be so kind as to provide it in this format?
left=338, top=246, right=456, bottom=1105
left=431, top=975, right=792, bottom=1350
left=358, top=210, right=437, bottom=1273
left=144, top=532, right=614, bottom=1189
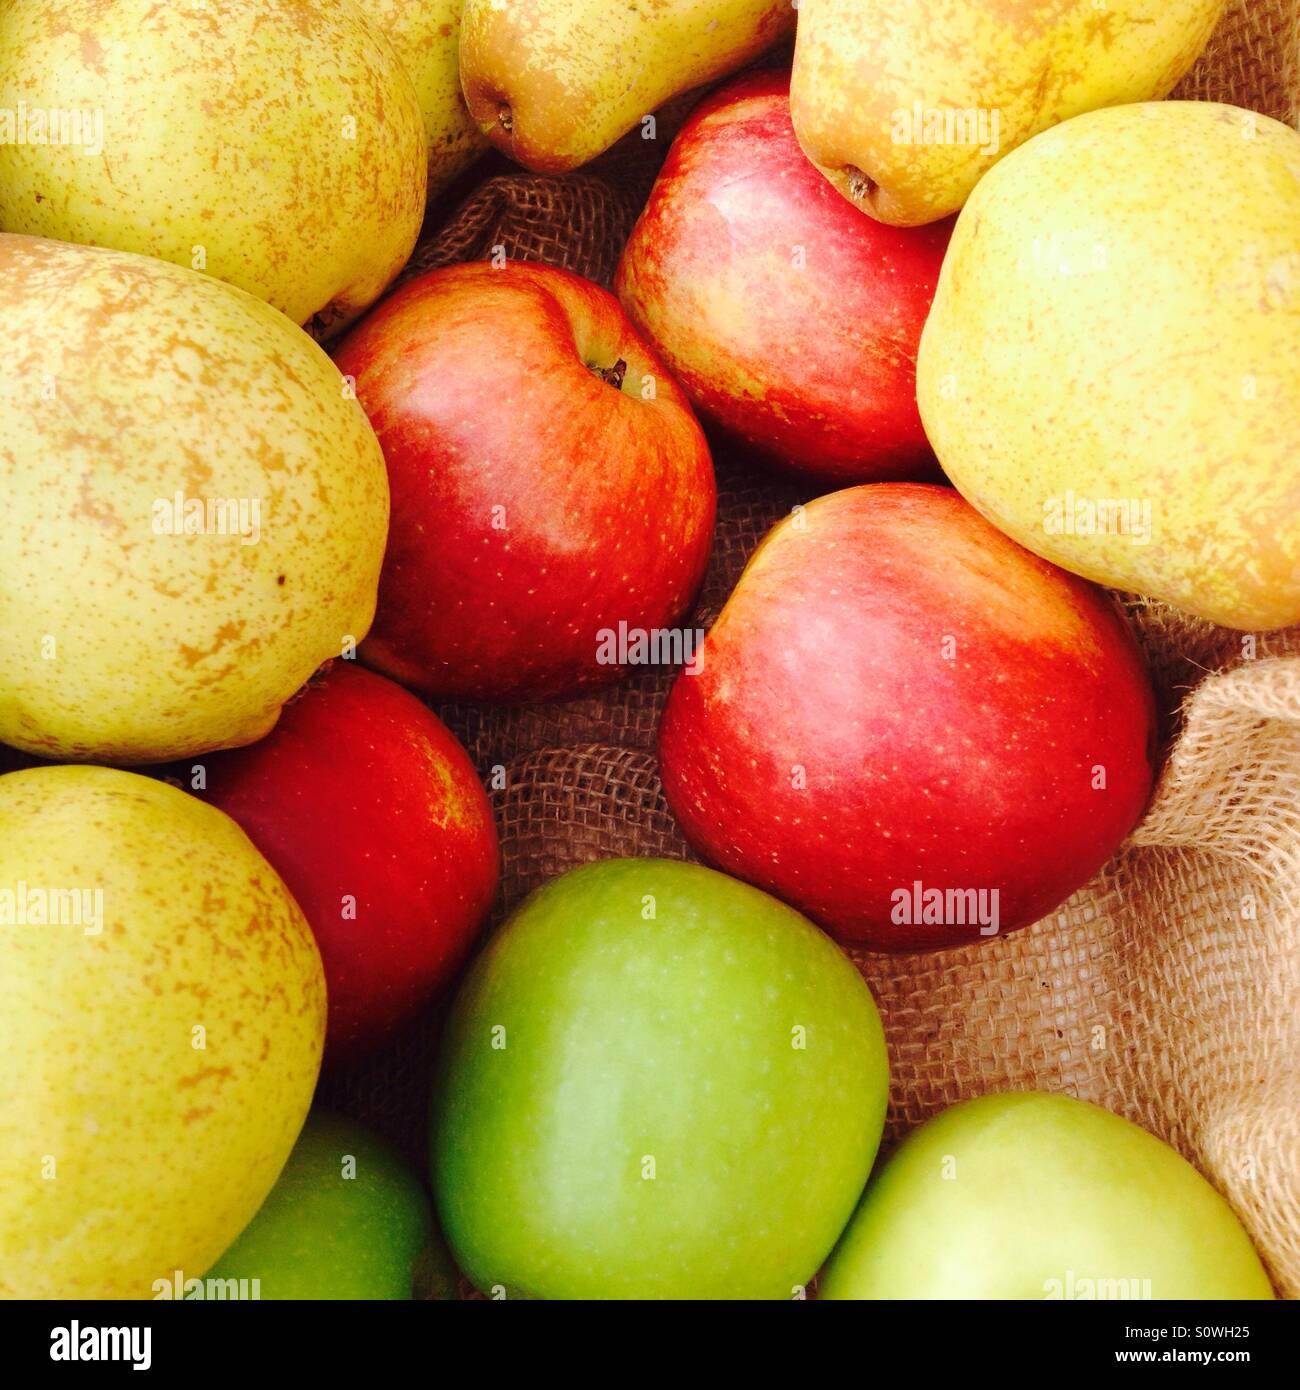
left=207, top=1111, right=436, bottom=1298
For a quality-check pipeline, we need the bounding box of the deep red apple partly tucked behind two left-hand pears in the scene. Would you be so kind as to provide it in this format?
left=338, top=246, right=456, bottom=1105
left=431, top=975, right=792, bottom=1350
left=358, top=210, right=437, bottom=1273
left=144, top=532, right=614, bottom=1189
left=171, top=662, right=498, bottom=1062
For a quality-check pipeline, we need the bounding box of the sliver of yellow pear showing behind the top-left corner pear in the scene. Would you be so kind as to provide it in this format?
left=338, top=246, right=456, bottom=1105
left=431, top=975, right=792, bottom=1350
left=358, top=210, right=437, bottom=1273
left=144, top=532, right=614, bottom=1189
left=357, top=0, right=488, bottom=199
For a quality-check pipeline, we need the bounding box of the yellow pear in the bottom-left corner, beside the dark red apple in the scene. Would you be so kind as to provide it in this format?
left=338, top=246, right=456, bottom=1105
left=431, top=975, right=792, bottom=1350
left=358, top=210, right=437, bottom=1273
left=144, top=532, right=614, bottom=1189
left=0, top=767, right=325, bottom=1298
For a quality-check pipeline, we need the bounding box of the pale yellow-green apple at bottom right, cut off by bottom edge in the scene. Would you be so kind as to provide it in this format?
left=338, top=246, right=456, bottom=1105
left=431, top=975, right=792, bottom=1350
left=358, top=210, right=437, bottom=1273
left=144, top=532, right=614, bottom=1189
left=820, top=1091, right=1272, bottom=1300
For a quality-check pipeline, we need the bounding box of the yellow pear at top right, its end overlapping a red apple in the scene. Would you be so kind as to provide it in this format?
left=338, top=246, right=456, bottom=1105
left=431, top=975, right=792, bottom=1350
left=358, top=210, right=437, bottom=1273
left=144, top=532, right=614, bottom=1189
left=790, top=0, right=1224, bottom=227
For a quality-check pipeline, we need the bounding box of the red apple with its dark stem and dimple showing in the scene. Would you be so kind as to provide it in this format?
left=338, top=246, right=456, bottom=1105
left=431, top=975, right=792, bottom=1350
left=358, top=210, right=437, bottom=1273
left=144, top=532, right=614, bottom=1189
left=338, top=263, right=716, bottom=699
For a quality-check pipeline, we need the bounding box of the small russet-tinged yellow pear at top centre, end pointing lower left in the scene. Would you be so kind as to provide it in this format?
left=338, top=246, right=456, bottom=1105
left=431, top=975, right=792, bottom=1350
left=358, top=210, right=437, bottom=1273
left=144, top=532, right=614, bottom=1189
left=460, top=0, right=795, bottom=174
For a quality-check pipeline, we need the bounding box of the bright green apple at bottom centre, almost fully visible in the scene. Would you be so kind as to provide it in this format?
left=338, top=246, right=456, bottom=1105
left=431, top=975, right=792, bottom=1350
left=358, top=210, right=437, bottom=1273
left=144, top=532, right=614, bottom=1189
left=432, top=859, right=888, bottom=1298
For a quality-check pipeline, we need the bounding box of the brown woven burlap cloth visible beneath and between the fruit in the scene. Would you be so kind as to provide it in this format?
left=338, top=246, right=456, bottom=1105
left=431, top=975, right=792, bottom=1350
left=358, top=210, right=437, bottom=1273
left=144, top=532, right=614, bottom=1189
left=318, top=0, right=1300, bottom=1297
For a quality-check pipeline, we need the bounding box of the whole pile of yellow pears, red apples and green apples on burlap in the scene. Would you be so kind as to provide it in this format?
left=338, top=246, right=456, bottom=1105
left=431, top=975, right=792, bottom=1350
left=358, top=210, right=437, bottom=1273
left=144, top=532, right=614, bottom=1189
left=0, top=0, right=1300, bottom=1298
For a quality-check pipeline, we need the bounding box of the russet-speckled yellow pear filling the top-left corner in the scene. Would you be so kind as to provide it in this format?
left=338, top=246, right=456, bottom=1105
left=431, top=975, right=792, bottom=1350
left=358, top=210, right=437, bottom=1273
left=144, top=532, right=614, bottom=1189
left=0, top=0, right=427, bottom=332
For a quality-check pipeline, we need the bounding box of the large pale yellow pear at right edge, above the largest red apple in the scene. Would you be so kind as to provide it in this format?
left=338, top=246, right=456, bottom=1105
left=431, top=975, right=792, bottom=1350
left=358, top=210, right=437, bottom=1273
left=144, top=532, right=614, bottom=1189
left=916, top=101, right=1300, bottom=628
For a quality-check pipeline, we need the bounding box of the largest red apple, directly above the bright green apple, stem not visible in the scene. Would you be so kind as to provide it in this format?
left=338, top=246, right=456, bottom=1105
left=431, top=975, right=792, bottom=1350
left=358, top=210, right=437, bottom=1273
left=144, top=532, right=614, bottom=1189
left=659, top=482, right=1155, bottom=951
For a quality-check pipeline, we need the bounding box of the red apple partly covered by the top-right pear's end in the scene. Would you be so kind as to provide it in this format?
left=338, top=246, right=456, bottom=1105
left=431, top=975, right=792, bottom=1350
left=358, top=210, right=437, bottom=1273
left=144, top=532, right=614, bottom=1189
left=615, top=72, right=951, bottom=484
